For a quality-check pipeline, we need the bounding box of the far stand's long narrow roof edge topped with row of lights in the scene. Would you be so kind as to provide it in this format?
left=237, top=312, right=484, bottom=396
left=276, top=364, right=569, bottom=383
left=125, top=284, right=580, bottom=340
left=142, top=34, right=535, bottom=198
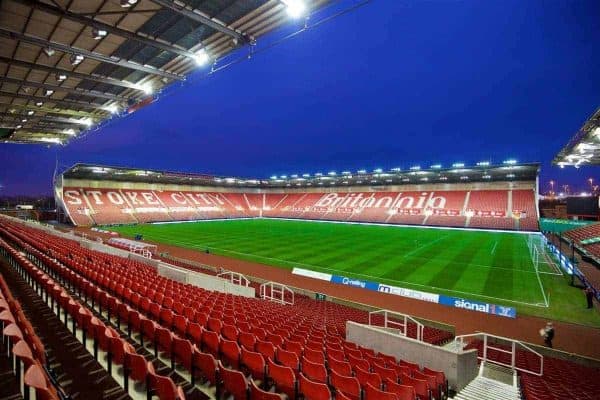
left=62, top=161, right=540, bottom=188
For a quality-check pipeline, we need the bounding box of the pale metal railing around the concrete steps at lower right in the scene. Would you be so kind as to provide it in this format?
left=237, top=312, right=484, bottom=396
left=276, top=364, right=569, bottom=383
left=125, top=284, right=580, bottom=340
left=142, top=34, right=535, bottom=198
left=454, top=332, right=544, bottom=376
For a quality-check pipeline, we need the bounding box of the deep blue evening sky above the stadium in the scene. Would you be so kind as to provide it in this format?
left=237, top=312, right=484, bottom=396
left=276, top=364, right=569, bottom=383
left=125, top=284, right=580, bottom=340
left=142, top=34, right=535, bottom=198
left=0, top=0, right=600, bottom=195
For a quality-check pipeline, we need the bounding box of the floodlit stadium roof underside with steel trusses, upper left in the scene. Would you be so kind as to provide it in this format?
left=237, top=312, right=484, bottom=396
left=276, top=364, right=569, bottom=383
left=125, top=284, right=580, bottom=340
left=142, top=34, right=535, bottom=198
left=0, top=0, right=330, bottom=144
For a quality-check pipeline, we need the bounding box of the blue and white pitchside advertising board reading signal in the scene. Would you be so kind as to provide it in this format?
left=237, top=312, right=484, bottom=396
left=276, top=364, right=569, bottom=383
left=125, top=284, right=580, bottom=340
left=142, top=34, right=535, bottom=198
left=292, top=268, right=517, bottom=318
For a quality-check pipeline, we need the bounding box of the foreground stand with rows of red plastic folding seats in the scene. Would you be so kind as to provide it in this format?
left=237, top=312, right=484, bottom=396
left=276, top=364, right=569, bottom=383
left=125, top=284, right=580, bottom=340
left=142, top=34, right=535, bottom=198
left=0, top=218, right=458, bottom=399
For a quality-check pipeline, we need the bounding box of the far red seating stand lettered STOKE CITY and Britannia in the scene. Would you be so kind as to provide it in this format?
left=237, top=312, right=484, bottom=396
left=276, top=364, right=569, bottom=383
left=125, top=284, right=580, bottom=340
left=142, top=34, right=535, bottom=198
left=63, top=187, right=538, bottom=230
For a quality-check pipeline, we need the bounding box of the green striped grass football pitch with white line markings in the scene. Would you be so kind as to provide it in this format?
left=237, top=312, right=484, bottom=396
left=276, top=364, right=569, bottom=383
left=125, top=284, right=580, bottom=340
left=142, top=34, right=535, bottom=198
left=111, top=219, right=600, bottom=326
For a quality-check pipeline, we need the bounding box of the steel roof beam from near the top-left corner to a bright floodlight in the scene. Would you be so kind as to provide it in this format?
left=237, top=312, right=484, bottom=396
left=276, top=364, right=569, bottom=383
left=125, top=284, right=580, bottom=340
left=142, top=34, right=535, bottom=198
left=14, top=0, right=195, bottom=58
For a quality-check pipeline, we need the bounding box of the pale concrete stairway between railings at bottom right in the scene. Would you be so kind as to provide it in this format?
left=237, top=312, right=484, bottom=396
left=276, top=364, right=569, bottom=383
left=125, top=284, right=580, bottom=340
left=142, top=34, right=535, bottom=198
left=454, top=363, right=521, bottom=400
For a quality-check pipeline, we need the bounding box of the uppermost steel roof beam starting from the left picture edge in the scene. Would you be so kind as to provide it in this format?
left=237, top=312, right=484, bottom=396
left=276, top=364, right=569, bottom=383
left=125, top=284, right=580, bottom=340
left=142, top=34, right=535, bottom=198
left=0, top=28, right=185, bottom=81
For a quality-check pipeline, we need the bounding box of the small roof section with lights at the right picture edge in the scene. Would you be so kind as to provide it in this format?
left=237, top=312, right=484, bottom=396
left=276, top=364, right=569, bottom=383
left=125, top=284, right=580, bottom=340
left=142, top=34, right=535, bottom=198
left=552, top=108, right=600, bottom=167
